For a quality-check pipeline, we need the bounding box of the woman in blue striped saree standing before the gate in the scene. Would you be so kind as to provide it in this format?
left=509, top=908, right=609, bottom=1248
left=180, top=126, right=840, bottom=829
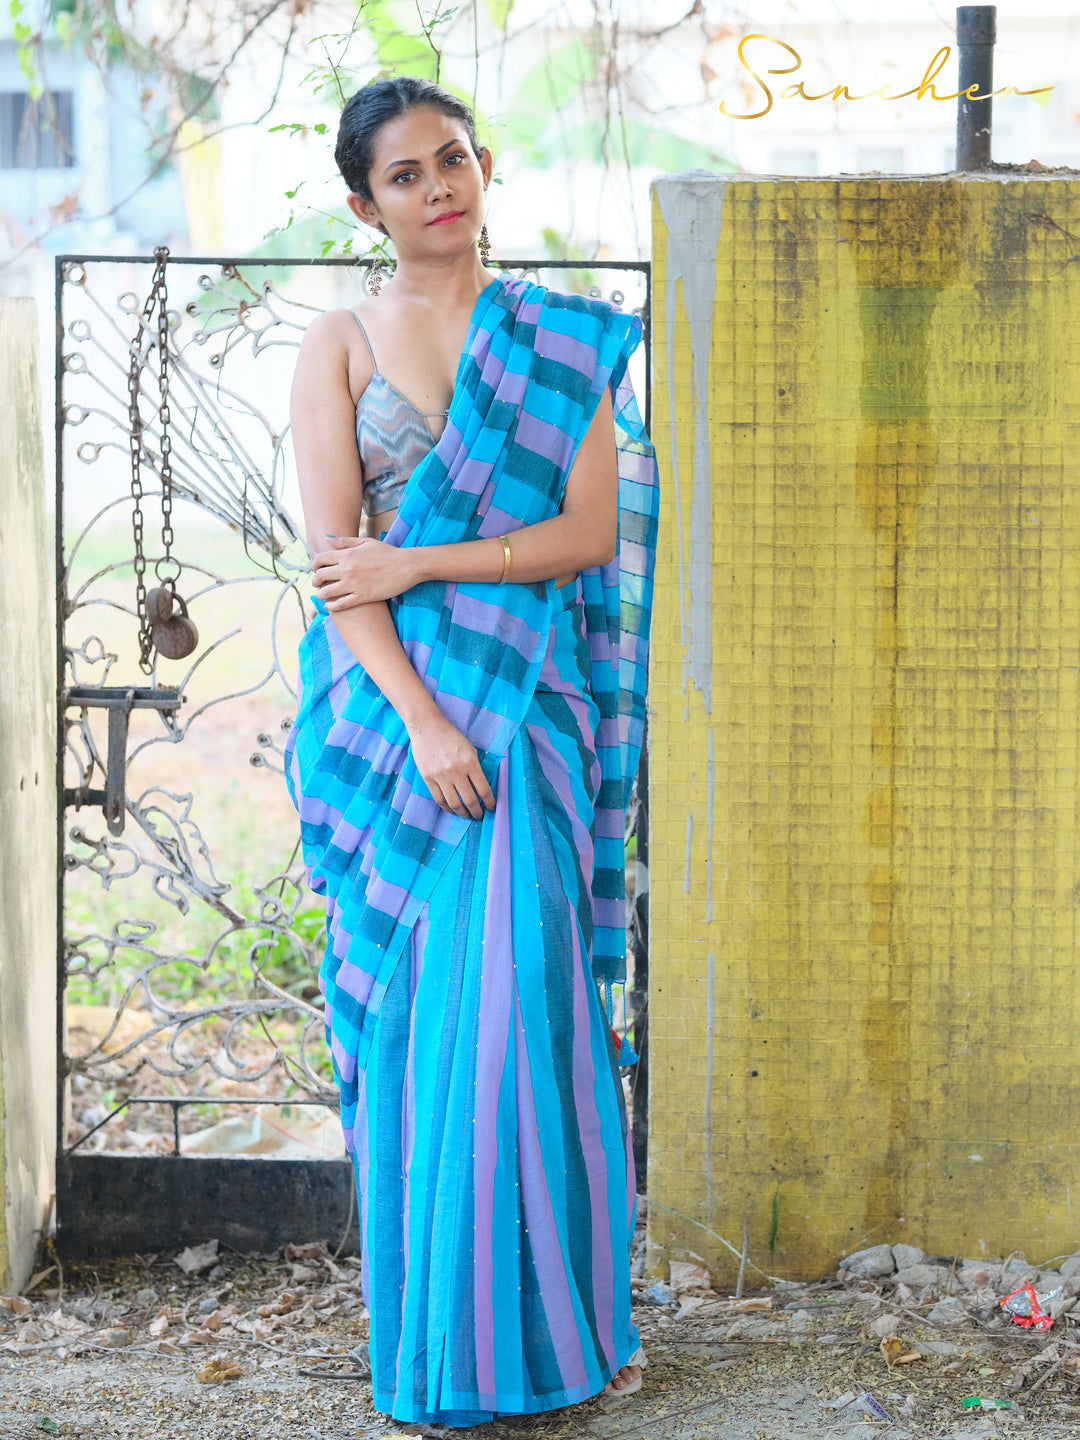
left=287, top=76, right=657, bottom=1427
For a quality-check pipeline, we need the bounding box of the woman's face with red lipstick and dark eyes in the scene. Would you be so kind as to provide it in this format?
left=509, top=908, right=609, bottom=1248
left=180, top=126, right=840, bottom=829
left=348, top=105, right=491, bottom=259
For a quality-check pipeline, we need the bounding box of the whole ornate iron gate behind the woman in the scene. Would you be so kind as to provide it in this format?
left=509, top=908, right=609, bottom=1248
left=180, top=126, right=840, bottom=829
left=56, top=255, right=651, bottom=1256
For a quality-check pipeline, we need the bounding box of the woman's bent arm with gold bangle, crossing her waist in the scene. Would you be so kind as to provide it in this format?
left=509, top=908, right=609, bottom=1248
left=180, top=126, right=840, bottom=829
left=314, top=387, right=619, bottom=615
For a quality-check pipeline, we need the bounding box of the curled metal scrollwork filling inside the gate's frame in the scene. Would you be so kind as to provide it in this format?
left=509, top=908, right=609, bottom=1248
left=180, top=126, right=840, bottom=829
left=58, top=256, right=645, bottom=1151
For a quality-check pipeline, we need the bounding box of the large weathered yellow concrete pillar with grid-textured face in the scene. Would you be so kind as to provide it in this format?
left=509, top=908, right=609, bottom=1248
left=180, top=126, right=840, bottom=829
left=648, top=171, right=1080, bottom=1282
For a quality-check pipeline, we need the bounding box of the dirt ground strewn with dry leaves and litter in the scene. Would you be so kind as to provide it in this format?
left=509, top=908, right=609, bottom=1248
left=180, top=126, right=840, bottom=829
left=0, top=1197, right=1080, bottom=1440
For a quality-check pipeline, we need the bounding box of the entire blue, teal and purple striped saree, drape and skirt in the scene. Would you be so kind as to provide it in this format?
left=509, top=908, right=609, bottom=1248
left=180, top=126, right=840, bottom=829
left=285, top=276, right=657, bottom=1426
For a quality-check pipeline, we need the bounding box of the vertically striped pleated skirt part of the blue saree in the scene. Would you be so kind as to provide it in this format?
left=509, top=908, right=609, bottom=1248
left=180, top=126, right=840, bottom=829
left=354, top=580, right=638, bottom=1426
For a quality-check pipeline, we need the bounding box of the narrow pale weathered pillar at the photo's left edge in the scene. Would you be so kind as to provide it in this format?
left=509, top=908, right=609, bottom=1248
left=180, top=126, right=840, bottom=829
left=0, top=297, right=56, bottom=1293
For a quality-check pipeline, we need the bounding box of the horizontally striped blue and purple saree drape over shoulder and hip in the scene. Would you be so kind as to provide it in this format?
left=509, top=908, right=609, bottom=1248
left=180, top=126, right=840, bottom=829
left=285, top=276, right=658, bottom=1152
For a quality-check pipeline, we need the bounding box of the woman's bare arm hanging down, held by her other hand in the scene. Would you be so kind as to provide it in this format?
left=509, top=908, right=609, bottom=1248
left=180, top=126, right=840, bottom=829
left=289, top=312, right=495, bottom=818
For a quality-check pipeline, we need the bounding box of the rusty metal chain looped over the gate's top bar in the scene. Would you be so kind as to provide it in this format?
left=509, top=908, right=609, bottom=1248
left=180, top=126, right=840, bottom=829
left=128, top=245, right=180, bottom=675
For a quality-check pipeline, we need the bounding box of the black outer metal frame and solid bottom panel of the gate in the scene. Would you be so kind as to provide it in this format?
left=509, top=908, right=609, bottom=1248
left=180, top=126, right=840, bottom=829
left=55, top=253, right=652, bottom=1259
